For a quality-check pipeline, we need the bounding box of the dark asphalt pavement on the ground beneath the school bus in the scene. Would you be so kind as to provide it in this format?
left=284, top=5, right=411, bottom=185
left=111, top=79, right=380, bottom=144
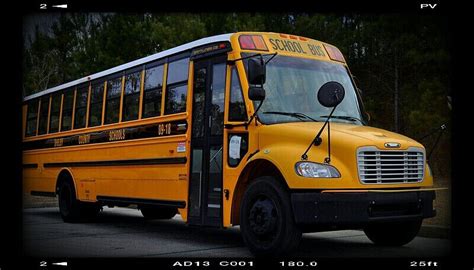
left=23, top=207, right=451, bottom=259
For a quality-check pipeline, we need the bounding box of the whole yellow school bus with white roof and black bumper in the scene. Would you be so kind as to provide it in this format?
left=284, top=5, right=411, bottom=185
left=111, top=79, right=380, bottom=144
left=23, top=32, right=435, bottom=255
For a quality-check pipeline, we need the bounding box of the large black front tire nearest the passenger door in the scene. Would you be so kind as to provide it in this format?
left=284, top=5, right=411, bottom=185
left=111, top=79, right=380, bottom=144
left=240, top=176, right=301, bottom=257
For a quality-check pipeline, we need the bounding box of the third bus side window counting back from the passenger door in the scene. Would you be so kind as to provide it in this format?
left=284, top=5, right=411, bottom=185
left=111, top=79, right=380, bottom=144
left=122, top=71, right=142, bottom=121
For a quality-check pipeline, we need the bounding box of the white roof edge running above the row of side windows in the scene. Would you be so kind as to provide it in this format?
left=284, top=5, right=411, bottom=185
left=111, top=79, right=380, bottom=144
left=23, top=33, right=234, bottom=101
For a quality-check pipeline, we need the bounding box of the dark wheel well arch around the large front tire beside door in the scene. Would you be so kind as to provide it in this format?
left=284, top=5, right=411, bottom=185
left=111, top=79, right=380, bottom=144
left=231, top=159, right=290, bottom=225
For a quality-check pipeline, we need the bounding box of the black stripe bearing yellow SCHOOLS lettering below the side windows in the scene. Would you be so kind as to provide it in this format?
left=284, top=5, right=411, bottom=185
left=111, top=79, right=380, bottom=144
left=23, top=120, right=188, bottom=150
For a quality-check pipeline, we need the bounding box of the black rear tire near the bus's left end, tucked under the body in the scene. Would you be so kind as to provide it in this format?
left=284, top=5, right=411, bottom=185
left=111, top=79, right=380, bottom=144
left=58, top=181, right=100, bottom=223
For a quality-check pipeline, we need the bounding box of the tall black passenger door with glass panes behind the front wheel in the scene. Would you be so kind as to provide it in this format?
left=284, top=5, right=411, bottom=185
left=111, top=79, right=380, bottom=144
left=188, top=56, right=227, bottom=227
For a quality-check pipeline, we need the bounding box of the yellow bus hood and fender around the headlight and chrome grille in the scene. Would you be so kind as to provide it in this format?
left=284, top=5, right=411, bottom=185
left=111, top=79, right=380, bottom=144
left=251, top=122, right=432, bottom=189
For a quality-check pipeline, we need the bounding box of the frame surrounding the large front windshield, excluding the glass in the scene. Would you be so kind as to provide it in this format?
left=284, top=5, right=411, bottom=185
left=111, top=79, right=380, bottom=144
left=241, top=52, right=368, bottom=126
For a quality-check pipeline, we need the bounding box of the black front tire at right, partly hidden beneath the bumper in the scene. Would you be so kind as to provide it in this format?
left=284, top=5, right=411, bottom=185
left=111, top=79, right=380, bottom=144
left=364, top=219, right=422, bottom=246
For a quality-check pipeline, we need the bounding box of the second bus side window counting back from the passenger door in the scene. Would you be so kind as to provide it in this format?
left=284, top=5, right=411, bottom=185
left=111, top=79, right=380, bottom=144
left=142, top=65, right=164, bottom=118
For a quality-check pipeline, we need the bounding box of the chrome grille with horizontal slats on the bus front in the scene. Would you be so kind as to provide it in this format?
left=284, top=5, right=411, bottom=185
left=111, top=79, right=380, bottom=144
left=357, top=147, right=425, bottom=184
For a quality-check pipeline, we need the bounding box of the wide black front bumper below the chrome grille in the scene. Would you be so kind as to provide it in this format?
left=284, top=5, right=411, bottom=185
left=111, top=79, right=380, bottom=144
left=291, top=191, right=436, bottom=226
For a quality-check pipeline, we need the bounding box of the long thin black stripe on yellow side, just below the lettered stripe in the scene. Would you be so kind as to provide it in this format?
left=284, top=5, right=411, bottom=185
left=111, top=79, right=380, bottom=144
left=43, top=157, right=187, bottom=168
